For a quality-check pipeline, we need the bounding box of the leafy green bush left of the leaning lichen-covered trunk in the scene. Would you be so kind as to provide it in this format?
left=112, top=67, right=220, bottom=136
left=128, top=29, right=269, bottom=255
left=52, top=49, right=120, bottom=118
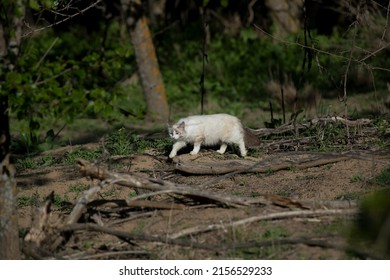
left=0, top=20, right=135, bottom=150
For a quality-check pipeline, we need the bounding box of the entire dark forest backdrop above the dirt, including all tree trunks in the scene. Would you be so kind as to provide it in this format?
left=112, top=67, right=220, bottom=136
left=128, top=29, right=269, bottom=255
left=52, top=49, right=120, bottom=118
left=0, top=0, right=390, bottom=259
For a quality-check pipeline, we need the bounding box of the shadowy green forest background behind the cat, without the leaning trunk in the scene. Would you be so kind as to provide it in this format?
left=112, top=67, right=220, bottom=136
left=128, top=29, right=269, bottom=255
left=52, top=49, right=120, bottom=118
left=1, top=0, right=390, bottom=151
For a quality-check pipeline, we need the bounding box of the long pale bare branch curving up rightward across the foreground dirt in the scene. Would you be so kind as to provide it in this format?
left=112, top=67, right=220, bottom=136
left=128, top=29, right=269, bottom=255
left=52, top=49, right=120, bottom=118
left=168, top=209, right=357, bottom=239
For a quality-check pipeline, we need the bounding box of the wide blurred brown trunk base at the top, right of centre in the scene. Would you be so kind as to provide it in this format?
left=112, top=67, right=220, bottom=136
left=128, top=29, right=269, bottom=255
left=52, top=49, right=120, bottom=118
left=265, top=0, right=303, bottom=35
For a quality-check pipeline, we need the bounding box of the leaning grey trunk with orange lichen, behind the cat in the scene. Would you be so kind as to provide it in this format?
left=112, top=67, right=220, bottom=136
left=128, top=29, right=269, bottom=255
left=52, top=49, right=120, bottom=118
left=122, top=0, right=169, bottom=121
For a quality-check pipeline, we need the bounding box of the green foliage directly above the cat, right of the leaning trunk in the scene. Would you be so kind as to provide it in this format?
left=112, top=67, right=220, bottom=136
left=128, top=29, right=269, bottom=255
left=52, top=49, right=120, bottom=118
left=159, top=29, right=324, bottom=116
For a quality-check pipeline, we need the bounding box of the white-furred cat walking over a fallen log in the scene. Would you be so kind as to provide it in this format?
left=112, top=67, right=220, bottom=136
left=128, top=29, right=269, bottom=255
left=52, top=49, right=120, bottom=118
left=168, top=114, right=247, bottom=158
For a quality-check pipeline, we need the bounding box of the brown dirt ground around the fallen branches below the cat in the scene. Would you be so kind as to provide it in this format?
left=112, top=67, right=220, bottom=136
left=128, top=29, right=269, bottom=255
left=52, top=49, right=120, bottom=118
left=17, top=132, right=389, bottom=259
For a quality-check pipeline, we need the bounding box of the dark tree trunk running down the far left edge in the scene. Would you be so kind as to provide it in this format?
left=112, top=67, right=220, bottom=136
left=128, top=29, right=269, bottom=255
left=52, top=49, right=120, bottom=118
left=0, top=0, right=26, bottom=259
